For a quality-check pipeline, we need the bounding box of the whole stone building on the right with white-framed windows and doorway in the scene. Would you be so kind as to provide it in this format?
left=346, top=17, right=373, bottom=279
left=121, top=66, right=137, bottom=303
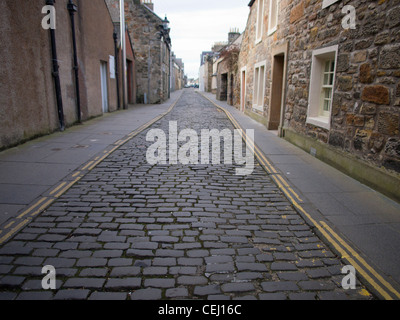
left=236, top=0, right=400, bottom=198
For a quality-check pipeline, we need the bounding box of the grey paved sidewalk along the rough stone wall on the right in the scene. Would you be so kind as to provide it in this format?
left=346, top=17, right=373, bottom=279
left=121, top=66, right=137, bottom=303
left=201, top=92, right=400, bottom=298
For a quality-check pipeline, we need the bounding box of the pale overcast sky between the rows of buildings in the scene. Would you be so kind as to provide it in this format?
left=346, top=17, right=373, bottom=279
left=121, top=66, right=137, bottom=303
left=153, top=0, right=250, bottom=79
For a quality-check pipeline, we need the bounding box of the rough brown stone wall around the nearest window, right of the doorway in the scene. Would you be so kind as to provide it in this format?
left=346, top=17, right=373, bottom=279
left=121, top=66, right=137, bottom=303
left=285, top=0, right=400, bottom=172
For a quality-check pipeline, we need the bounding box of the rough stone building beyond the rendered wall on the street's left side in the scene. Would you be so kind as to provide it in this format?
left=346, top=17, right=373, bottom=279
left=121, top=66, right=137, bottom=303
left=123, top=0, right=171, bottom=104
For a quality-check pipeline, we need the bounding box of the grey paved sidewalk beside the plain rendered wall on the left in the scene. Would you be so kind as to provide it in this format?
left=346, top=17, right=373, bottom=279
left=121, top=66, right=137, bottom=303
left=0, top=91, right=182, bottom=230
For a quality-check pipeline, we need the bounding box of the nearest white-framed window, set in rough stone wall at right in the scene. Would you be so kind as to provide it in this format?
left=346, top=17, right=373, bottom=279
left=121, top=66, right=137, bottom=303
left=307, top=45, right=338, bottom=129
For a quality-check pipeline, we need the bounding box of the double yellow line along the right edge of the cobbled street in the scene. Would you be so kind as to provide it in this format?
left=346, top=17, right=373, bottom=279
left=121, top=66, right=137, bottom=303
left=201, top=94, right=400, bottom=300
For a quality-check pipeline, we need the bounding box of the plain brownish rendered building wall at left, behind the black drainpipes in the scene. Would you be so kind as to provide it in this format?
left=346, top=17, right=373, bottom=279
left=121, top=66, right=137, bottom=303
left=0, top=0, right=117, bottom=149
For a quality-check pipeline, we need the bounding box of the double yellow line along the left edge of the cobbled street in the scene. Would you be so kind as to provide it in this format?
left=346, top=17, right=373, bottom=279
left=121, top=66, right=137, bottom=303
left=0, top=93, right=182, bottom=245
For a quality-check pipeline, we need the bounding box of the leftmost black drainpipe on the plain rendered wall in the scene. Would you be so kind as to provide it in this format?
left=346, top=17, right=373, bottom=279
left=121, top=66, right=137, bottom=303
left=46, top=0, right=65, bottom=131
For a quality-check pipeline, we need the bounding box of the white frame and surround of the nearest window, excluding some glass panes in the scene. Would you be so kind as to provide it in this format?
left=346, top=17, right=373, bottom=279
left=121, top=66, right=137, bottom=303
left=307, top=45, right=339, bottom=130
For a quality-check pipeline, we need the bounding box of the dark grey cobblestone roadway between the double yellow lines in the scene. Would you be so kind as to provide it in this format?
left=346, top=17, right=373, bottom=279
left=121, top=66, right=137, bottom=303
left=0, top=90, right=372, bottom=300
